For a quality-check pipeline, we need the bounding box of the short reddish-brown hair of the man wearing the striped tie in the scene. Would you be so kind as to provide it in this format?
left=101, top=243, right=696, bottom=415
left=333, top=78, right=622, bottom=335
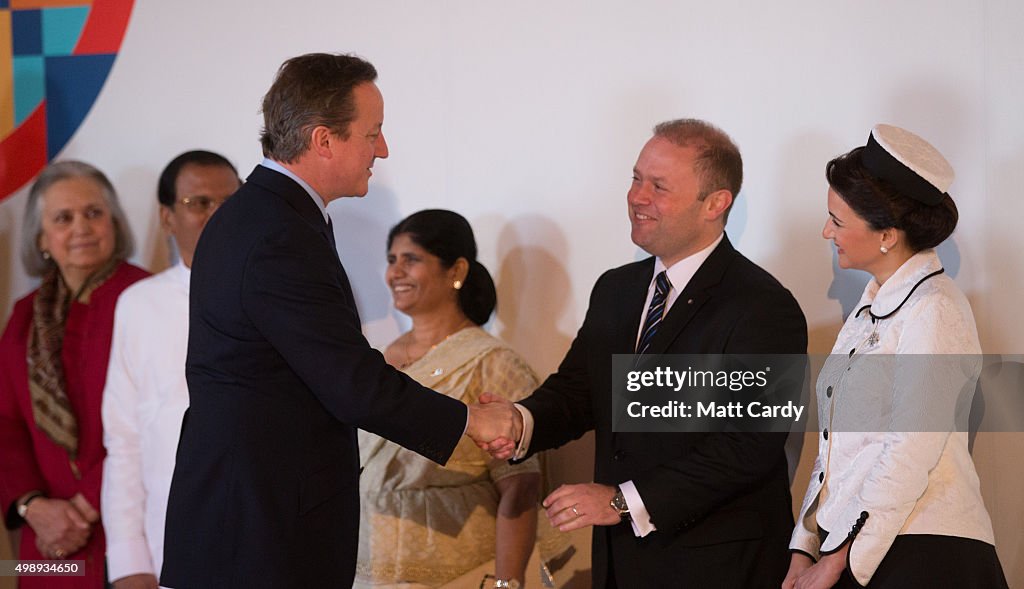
left=654, top=119, right=743, bottom=221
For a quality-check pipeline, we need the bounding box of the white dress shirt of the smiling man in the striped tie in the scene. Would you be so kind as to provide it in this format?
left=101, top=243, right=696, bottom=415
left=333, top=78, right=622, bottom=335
left=515, top=233, right=725, bottom=538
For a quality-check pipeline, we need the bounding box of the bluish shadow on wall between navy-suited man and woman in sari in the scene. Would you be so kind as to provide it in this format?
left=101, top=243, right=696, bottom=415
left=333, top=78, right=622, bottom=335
left=328, top=186, right=401, bottom=324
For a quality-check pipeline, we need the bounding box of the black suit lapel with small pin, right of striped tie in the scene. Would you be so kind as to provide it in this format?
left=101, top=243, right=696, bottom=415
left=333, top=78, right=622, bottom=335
left=647, top=236, right=736, bottom=353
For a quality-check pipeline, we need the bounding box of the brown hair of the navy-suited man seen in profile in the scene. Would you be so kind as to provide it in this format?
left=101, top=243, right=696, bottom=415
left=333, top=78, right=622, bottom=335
left=260, top=53, right=377, bottom=164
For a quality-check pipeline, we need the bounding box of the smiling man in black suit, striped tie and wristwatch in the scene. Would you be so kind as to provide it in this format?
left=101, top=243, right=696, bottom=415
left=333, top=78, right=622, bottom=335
left=493, top=120, right=807, bottom=589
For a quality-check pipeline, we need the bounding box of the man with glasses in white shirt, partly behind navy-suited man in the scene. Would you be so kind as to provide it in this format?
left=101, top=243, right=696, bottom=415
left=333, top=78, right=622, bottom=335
left=100, top=151, right=241, bottom=589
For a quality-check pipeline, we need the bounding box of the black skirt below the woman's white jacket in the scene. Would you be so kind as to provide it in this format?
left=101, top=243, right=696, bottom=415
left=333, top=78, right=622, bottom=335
left=834, top=534, right=1008, bottom=589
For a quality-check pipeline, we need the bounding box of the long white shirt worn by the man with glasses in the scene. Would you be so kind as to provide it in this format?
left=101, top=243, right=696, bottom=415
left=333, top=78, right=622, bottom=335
left=100, top=262, right=190, bottom=581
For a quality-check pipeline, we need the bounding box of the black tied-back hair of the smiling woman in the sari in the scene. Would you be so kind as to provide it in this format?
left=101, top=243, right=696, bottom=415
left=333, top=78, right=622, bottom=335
left=387, top=209, right=498, bottom=325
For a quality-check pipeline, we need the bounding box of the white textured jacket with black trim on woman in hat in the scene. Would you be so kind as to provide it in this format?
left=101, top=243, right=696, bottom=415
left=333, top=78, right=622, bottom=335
left=790, top=250, right=994, bottom=585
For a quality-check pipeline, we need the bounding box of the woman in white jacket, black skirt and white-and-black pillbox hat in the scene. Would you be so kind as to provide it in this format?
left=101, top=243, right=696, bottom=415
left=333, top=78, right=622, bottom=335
left=782, top=125, right=1007, bottom=589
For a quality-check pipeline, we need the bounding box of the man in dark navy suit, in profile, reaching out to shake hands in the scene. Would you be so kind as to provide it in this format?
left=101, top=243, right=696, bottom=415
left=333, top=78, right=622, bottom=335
left=161, top=53, right=516, bottom=588
